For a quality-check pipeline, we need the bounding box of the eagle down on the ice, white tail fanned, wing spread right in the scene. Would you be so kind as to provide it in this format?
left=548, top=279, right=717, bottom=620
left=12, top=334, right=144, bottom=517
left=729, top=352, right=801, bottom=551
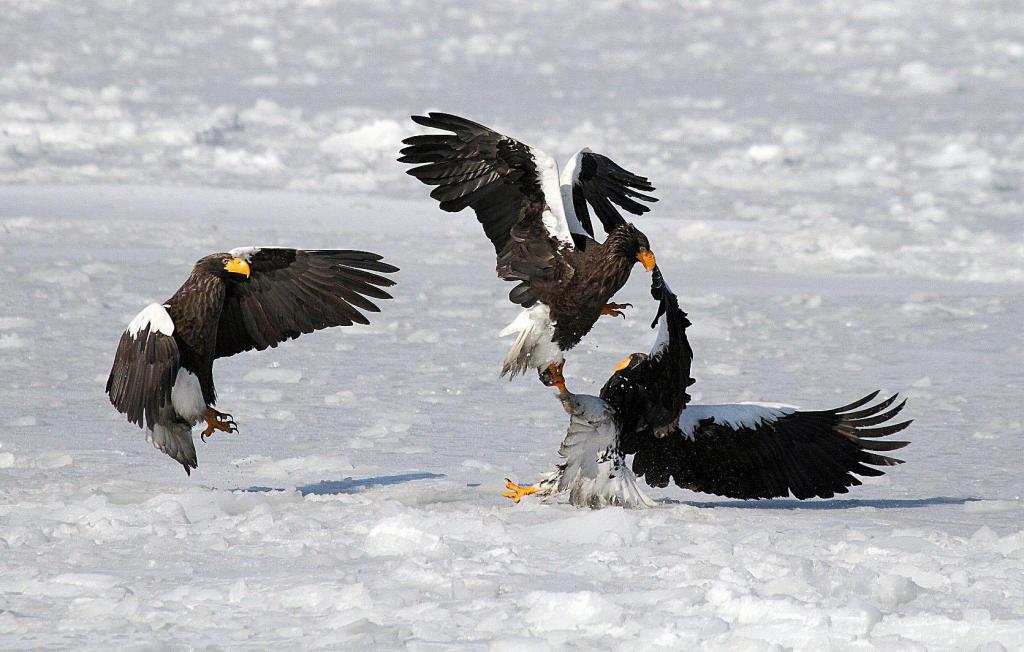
left=505, top=269, right=911, bottom=508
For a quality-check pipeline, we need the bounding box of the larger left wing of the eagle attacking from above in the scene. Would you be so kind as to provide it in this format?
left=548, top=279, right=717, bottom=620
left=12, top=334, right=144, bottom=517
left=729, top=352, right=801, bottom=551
left=398, top=113, right=573, bottom=307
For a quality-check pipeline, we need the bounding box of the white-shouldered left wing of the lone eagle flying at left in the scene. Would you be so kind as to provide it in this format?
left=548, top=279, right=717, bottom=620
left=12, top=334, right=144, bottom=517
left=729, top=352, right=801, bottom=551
left=106, top=303, right=181, bottom=430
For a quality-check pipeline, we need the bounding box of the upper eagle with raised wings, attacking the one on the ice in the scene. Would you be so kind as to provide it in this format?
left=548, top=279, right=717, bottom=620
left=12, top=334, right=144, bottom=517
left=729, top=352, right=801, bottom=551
left=398, top=113, right=657, bottom=385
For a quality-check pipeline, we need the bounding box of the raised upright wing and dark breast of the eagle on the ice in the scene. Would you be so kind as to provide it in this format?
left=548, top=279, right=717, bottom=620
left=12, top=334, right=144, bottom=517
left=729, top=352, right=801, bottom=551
left=601, top=267, right=693, bottom=440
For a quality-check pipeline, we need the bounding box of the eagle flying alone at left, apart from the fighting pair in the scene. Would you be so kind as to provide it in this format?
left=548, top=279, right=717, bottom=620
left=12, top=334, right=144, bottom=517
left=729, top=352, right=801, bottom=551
left=106, top=247, right=398, bottom=475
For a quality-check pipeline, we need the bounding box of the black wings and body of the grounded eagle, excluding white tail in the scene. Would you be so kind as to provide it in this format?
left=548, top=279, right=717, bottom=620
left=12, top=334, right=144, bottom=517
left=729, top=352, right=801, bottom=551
left=601, top=271, right=910, bottom=499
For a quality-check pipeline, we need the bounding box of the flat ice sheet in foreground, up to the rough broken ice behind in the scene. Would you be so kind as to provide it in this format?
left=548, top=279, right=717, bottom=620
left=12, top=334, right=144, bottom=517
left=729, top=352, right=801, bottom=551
left=0, top=186, right=1024, bottom=650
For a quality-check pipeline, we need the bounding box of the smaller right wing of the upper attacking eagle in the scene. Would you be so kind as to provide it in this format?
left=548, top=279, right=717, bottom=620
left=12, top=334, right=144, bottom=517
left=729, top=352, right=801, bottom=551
left=561, top=148, right=657, bottom=237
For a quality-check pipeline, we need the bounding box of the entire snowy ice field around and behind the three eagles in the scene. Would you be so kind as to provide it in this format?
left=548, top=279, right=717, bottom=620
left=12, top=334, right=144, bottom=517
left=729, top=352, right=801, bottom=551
left=0, top=0, right=1024, bottom=652
